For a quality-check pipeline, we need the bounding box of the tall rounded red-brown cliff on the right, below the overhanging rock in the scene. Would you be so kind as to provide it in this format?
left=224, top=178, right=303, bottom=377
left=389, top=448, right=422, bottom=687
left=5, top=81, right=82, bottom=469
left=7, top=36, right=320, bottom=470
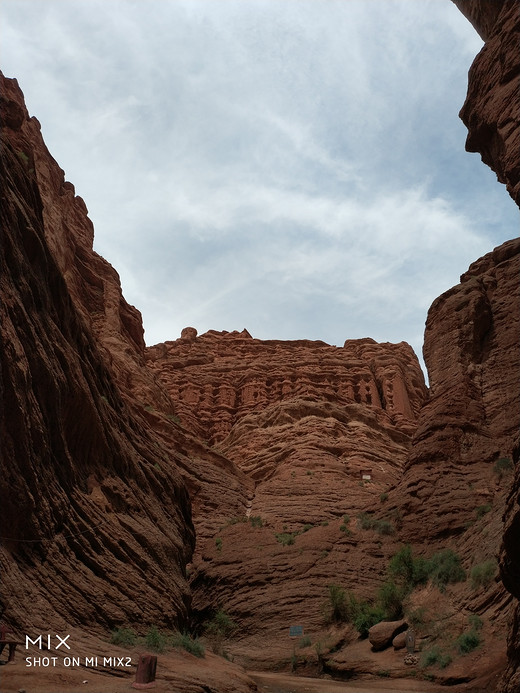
left=394, top=240, right=520, bottom=542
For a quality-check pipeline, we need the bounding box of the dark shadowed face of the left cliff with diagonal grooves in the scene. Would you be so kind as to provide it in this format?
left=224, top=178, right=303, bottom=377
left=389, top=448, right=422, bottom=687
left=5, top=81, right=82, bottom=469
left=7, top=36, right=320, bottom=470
left=0, top=78, right=194, bottom=632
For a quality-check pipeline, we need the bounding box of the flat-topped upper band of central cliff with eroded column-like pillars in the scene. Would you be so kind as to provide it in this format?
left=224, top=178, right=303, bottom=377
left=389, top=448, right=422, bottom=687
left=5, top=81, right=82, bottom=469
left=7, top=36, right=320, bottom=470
left=146, top=328, right=425, bottom=444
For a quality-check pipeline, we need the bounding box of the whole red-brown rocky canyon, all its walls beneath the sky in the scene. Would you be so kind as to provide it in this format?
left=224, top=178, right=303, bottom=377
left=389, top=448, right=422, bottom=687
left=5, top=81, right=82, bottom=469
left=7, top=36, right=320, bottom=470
left=0, top=0, right=520, bottom=693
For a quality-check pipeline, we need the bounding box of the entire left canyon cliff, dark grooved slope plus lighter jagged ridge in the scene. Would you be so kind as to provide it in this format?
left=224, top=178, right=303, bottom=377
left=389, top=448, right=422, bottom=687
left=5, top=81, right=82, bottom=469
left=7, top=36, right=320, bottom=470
left=0, top=76, right=253, bottom=691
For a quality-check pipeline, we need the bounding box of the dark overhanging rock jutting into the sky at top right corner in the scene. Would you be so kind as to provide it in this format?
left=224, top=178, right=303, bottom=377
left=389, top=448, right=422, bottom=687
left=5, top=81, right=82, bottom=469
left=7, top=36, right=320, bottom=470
left=456, top=0, right=520, bottom=204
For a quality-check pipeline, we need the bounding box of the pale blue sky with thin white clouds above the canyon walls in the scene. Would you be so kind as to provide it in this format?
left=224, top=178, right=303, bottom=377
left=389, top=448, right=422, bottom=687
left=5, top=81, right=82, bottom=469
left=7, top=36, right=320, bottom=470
left=0, top=0, right=518, bottom=374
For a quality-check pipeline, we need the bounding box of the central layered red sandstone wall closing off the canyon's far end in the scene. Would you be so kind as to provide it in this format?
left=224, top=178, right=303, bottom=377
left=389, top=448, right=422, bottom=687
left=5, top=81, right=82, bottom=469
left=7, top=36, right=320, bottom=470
left=147, top=328, right=427, bottom=666
